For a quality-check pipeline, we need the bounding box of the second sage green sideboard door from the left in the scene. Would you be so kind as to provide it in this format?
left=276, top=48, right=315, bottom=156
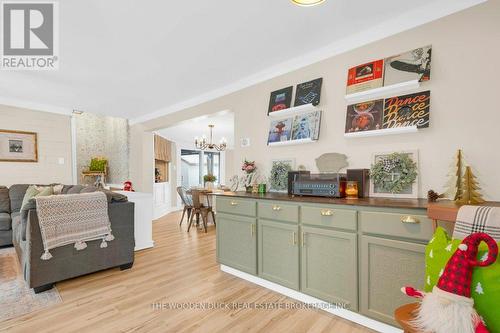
left=260, top=219, right=299, bottom=290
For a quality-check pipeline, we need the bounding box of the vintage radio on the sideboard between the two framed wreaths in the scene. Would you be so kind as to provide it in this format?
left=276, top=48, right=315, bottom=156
left=293, top=173, right=347, bottom=198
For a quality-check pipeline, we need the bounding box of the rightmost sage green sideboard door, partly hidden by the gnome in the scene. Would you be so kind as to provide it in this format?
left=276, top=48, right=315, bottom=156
left=360, top=236, right=425, bottom=325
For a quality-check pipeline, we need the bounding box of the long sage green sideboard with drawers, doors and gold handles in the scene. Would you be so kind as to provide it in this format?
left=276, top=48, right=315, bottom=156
left=217, top=193, right=433, bottom=326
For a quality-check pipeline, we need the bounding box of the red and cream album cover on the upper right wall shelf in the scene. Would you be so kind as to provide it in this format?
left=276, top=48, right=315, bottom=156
left=346, top=60, right=384, bottom=94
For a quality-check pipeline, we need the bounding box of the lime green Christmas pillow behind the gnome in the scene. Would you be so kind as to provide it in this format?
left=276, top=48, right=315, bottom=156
left=424, top=227, right=500, bottom=333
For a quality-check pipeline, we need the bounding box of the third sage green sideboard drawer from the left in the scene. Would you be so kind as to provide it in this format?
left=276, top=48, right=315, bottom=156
left=301, top=206, right=357, bottom=231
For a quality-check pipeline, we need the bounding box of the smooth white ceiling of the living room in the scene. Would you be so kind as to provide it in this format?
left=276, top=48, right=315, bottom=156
left=0, top=0, right=484, bottom=121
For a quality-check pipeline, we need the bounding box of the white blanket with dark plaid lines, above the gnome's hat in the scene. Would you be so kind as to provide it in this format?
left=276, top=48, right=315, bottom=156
left=453, top=206, right=500, bottom=242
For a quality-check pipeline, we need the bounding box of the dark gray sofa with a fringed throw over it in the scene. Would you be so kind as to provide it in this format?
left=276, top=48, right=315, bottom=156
left=0, top=184, right=135, bottom=293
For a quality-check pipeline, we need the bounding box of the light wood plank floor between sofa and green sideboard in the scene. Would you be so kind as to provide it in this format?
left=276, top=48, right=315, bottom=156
left=0, top=213, right=372, bottom=333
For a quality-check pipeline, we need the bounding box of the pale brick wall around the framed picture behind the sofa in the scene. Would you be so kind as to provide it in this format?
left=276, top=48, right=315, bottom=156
left=0, top=105, right=72, bottom=186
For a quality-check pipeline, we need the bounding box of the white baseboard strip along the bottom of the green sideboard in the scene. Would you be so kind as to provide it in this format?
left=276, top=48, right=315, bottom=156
left=220, top=265, right=403, bottom=333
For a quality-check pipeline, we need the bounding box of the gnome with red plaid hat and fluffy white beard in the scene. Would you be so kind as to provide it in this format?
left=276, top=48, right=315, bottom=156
left=401, top=232, right=498, bottom=333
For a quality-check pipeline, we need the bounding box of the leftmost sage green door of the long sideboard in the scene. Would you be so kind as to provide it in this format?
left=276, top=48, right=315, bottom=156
left=216, top=213, right=257, bottom=275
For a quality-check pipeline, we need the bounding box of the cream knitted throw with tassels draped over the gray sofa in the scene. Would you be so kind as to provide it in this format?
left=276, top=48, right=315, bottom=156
left=35, top=192, right=114, bottom=260
